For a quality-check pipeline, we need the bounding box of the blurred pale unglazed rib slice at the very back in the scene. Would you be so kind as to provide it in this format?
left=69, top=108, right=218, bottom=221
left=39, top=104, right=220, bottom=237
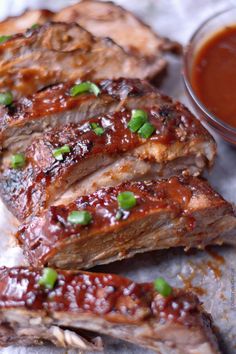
left=53, top=0, right=180, bottom=61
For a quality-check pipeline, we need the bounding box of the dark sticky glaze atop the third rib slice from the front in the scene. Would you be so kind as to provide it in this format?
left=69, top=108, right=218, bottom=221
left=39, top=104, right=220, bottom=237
left=0, top=103, right=208, bottom=220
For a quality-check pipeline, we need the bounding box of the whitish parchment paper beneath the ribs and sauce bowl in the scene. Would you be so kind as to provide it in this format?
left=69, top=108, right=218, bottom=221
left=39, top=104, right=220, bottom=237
left=0, top=0, right=236, bottom=354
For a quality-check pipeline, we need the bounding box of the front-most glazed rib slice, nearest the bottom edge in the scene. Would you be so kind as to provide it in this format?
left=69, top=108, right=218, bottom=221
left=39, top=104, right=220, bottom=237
left=0, top=268, right=220, bottom=354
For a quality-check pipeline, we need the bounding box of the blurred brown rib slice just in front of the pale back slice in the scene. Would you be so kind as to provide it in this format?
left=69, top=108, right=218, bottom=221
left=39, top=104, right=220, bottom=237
left=0, top=22, right=169, bottom=98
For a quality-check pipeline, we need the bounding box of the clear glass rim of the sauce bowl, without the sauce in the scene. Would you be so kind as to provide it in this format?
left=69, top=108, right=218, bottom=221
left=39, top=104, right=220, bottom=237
left=182, top=5, right=236, bottom=135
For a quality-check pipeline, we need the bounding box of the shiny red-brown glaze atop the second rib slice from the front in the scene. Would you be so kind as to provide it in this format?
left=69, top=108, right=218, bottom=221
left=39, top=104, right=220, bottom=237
left=17, top=177, right=229, bottom=264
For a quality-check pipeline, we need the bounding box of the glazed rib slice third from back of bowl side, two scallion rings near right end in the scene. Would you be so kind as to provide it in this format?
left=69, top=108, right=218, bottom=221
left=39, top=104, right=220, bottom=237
left=0, top=103, right=215, bottom=221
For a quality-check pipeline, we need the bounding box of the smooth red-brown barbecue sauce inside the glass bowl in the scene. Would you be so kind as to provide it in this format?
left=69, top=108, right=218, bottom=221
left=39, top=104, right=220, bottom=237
left=191, top=26, right=236, bottom=127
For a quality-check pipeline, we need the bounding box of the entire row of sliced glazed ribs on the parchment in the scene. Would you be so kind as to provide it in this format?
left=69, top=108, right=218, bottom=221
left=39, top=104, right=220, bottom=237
left=0, top=0, right=236, bottom=354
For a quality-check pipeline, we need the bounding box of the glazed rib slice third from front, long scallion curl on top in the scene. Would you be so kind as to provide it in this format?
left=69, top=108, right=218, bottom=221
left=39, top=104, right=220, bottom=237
left=0, top=78, right=168, bottom=152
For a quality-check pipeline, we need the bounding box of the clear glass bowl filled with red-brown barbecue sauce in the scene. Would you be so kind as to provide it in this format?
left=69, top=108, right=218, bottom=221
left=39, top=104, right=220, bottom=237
left=183, top=7, right=236, bottom=145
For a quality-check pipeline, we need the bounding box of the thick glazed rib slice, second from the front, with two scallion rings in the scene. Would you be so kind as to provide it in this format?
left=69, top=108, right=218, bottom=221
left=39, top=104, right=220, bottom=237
left=17, top=177, right=236, bottom=268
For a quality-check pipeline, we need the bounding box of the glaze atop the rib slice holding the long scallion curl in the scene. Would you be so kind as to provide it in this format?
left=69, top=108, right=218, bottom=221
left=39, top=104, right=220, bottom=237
left=0, top=78, right=157, bottom=139
